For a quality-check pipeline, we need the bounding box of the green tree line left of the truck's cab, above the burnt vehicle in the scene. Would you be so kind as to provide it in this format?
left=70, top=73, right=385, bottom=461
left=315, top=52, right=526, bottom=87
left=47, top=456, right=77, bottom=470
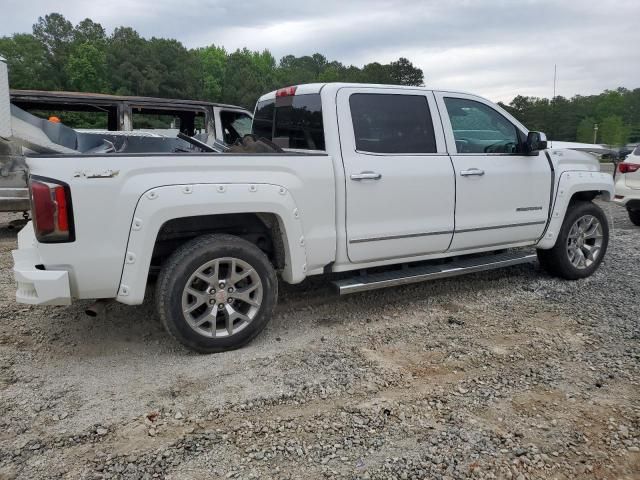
left=0, top=13, right=424, bottom=108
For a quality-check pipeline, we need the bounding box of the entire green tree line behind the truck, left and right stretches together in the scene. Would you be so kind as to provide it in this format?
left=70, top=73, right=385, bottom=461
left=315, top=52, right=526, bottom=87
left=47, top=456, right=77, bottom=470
left=0, top=13, right=640, bottom=145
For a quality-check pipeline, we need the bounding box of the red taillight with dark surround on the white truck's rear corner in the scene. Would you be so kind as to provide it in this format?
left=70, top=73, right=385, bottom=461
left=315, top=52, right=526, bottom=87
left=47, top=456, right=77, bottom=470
left=29, top=177, right=75, bottom=243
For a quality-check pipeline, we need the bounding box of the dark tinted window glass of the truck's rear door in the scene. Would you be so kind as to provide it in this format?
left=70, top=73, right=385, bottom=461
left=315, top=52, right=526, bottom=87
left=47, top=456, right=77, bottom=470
left=349, top=93, right=436, bottom=153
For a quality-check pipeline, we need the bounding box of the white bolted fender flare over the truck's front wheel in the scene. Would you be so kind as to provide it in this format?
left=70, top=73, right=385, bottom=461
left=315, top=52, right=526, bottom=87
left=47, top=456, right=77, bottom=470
left=536, top=171, right=614, bottom=250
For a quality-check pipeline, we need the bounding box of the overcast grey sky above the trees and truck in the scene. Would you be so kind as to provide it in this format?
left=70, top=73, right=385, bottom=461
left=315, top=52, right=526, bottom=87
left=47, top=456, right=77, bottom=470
left=0, top=0, right=640, bottom=101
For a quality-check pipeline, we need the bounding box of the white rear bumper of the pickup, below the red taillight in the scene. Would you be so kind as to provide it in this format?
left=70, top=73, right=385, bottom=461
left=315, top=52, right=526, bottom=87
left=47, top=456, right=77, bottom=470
left=11, top=222, right=71, bottom=305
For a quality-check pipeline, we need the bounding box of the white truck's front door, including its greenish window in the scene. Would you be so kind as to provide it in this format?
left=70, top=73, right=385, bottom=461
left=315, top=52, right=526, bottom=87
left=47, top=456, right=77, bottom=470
left=436, top=92, right=551, bottom=251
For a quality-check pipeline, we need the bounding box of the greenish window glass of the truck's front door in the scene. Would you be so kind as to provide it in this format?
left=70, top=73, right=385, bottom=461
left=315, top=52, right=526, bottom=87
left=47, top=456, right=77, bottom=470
left=444, top=98, right=521, bottom=153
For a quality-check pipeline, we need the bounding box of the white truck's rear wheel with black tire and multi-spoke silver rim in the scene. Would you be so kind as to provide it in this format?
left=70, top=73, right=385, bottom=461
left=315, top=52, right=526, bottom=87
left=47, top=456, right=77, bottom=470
left=156, top=234, right=278, bottom=353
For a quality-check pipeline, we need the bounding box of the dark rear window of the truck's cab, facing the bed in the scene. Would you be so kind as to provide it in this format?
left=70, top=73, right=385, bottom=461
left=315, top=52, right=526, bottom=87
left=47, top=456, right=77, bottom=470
left=252, top=93, right=325, bottom=150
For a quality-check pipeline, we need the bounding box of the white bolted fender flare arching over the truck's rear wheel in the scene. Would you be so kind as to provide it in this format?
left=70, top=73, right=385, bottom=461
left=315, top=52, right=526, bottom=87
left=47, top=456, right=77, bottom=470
left=116, top=183, right=307, bottom=305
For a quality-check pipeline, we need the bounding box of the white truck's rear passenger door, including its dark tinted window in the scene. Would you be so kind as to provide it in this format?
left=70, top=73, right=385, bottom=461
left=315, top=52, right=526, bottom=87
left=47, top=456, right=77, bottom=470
left=337, top=87, right=455, bottom=263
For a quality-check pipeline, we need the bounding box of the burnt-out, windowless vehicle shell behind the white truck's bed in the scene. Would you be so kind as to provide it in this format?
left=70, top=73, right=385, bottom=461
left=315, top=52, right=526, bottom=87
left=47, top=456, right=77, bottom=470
left=0, top=71, right=252, bottom=212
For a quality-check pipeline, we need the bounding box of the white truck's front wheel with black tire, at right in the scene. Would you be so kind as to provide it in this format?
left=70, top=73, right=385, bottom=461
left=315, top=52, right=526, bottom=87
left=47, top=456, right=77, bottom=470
left=537, top=201, right=609, bottom=280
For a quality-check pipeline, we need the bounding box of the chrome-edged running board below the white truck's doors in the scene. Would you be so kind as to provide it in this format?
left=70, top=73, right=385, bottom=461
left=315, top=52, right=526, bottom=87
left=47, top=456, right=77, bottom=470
left=332, top=251, right=537, bottom=295
